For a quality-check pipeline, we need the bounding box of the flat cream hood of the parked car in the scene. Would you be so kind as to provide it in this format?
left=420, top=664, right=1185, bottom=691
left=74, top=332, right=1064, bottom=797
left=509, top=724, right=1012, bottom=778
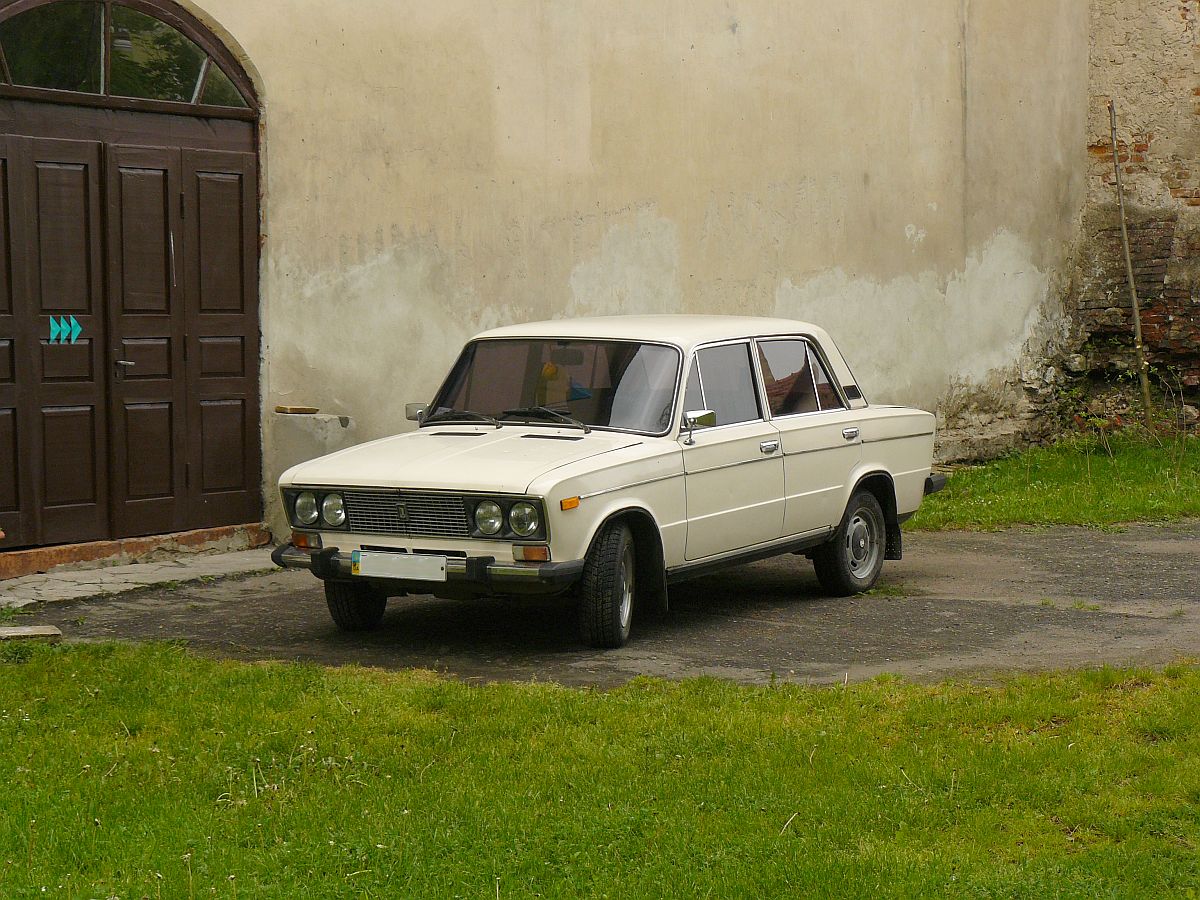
left=281, top=425, right=643, bottom=493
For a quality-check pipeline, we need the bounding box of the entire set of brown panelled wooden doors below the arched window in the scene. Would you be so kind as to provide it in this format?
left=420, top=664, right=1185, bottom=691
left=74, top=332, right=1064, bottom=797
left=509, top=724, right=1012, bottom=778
left=0, top=118, right=262, bottom=547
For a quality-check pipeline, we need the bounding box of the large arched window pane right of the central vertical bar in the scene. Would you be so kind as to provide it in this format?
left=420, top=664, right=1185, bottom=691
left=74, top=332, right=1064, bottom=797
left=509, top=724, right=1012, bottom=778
left=110, top=6, right=205, bottom=103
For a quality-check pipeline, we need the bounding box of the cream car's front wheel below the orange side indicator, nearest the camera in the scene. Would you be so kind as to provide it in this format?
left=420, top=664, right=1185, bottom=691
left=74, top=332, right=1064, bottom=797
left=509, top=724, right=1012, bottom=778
left=580, top=522, right=637, bottom=648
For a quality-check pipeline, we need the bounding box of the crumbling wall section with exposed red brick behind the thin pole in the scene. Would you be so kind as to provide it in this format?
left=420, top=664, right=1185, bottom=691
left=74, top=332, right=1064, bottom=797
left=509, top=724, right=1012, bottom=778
left=1070, top=0, right=1200, bottom=390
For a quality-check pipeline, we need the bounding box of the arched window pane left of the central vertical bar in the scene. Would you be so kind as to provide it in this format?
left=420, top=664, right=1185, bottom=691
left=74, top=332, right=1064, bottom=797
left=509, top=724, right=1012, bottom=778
left=0, top=0, right=104, bottom=94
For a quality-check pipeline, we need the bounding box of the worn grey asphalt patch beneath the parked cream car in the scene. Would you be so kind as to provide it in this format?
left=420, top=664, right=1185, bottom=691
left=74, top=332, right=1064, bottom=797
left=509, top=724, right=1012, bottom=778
left=9, top=522, right=1200, bottom=686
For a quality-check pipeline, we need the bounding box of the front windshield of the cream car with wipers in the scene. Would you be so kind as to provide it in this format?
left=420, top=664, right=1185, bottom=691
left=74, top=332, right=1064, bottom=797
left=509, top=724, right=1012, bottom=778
left=425, top=338, right=680, bottom=434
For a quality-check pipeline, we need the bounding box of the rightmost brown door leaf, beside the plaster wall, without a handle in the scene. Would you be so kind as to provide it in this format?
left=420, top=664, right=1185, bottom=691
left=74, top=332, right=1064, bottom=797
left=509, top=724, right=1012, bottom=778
left=182, top=150, right=262, bottom=527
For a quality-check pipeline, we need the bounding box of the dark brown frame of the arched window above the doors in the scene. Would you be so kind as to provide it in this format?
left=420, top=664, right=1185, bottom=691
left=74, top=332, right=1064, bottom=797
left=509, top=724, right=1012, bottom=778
left=0, top=0, right=259, bottom=120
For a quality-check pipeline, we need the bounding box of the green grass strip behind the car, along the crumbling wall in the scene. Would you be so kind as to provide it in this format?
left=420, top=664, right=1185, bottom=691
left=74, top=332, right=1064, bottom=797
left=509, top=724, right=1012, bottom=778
left=907, top=432, right=1200, bottom=530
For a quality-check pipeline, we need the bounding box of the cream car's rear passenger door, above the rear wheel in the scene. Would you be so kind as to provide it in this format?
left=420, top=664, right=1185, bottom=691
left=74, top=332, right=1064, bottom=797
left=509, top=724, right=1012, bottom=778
left=755, top=337, right=863, bottom=535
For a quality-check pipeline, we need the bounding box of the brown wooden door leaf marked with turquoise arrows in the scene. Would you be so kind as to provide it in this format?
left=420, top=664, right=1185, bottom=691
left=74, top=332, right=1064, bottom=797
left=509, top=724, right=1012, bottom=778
left=7, top=137, right=109, bottom=544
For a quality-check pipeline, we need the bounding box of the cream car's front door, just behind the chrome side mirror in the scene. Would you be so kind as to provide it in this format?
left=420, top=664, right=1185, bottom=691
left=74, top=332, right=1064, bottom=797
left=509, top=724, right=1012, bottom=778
left=679, top=341, right=784, bottom=559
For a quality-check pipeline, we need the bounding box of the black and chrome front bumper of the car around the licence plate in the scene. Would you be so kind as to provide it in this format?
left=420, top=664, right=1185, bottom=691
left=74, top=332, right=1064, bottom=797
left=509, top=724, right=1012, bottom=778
left=271, top=544, right=583, bottom=594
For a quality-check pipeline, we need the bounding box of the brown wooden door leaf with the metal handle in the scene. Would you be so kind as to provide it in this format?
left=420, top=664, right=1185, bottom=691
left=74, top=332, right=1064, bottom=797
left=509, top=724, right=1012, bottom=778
left=107, top=146, right=190, bottom=538
